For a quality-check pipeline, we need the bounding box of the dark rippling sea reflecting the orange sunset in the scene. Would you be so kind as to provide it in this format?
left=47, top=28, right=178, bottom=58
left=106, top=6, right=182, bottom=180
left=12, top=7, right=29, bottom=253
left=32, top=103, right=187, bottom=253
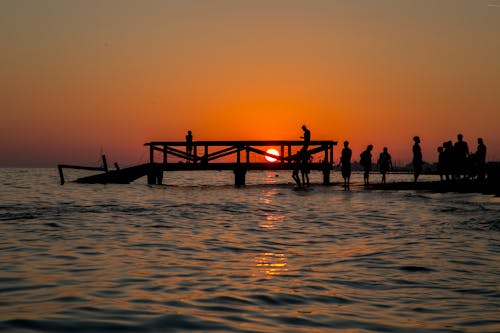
left=0, top=168, right=500, bottom=333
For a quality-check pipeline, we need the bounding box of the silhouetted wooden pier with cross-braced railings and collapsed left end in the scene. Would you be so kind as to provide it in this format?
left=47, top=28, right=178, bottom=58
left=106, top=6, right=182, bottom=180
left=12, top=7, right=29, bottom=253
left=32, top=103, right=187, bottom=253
left=58, top=140, right=337, bottom=186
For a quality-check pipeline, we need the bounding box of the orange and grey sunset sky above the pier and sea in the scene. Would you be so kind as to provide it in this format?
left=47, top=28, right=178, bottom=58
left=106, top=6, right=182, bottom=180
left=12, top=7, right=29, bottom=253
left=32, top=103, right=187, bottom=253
left=0, top=0, right=500, bottom=167
